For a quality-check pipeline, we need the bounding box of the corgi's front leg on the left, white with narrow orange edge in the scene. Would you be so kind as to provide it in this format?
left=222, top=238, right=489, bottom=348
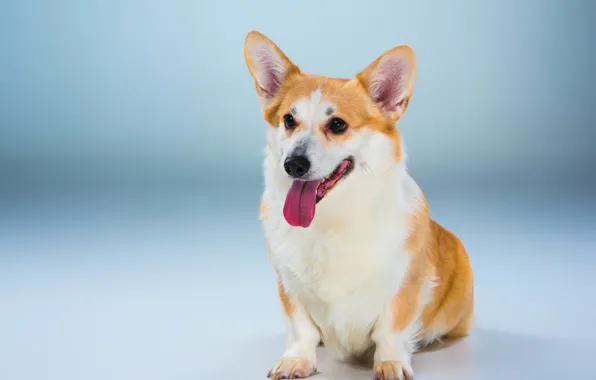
left=267, top=279, right=321, bottom=379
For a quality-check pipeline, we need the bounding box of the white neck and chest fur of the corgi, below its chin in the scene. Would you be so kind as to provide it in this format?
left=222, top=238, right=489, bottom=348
left=263, top=166, right=409, bottom=357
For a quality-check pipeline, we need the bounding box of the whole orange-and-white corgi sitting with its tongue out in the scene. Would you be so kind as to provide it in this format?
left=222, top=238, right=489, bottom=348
left=243, top=31, right=474, bottom=380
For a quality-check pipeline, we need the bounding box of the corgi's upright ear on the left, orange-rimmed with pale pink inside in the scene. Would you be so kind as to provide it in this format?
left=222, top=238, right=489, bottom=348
left=244, top=31, right=300, bottom=107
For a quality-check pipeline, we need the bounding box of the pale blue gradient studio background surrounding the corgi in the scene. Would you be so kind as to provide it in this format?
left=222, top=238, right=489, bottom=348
left=0, top=0, right=596, bottom=380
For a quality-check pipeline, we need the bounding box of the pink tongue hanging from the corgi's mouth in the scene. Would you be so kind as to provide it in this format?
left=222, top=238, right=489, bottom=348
left=284, top=180, right=321, bottom=228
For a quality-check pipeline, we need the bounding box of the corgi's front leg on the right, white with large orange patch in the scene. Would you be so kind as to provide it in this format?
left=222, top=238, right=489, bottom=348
left=372, top=281, right=433, bottom=380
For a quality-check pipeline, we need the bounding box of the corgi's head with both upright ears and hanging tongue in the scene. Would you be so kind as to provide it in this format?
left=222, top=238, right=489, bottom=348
left=244, top=31, right=416, bottom=227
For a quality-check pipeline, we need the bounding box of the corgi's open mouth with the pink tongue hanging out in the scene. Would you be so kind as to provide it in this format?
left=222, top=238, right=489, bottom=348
left=284, top=157, right=354, bottom=228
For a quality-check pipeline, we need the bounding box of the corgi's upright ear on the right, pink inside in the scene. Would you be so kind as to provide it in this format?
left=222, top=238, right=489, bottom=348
left=356, top=45, right=416, bottom=121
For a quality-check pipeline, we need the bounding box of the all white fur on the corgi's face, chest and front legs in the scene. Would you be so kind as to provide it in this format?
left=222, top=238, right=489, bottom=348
left=263, top=92, right=425, bottom=366
